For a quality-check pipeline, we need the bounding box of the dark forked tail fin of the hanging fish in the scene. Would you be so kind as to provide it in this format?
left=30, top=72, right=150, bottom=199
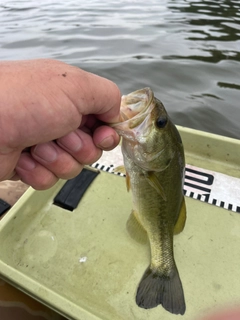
left=136, top=267, right=186, bottom=315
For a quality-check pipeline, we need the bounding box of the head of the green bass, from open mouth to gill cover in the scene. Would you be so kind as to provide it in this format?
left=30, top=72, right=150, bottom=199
left=111, top=88, right=178, bottom=171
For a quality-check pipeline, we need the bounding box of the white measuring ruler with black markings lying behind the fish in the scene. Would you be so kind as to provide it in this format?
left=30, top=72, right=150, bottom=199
left=92, top=146, right=240, bottom=213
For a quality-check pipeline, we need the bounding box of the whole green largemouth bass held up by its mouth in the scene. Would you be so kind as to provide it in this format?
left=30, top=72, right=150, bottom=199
left=112, top=88, right=186, bottom=314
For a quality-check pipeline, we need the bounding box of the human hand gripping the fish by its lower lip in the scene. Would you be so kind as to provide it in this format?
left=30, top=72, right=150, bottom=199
left=0, top=60, right=121, bottom=189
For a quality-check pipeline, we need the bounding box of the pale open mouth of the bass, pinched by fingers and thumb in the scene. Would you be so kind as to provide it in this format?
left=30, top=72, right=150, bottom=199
left=111, top=87, right=154, bottom=138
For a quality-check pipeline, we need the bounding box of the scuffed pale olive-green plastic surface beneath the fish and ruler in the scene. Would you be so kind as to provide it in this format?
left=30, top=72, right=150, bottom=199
left=0, top=129, right=240, bottom=320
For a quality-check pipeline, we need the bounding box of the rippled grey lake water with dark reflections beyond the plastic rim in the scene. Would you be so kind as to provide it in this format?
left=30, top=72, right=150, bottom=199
left=0, top=0, right=240, bottom=138
